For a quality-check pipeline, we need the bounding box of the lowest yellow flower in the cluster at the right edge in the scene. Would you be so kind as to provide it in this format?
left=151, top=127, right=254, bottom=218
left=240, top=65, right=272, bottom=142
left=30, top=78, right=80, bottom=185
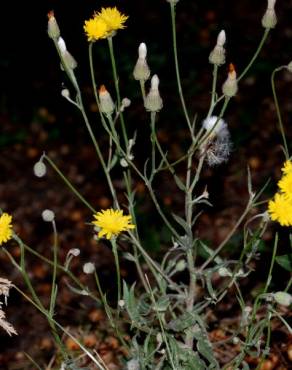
left=268, top=193, right=292, bottom=226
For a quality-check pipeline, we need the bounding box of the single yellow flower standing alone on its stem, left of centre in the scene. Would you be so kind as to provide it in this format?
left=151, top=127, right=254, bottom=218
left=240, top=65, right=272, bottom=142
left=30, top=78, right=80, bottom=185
left=92, top=208, right=135, bottom=239
